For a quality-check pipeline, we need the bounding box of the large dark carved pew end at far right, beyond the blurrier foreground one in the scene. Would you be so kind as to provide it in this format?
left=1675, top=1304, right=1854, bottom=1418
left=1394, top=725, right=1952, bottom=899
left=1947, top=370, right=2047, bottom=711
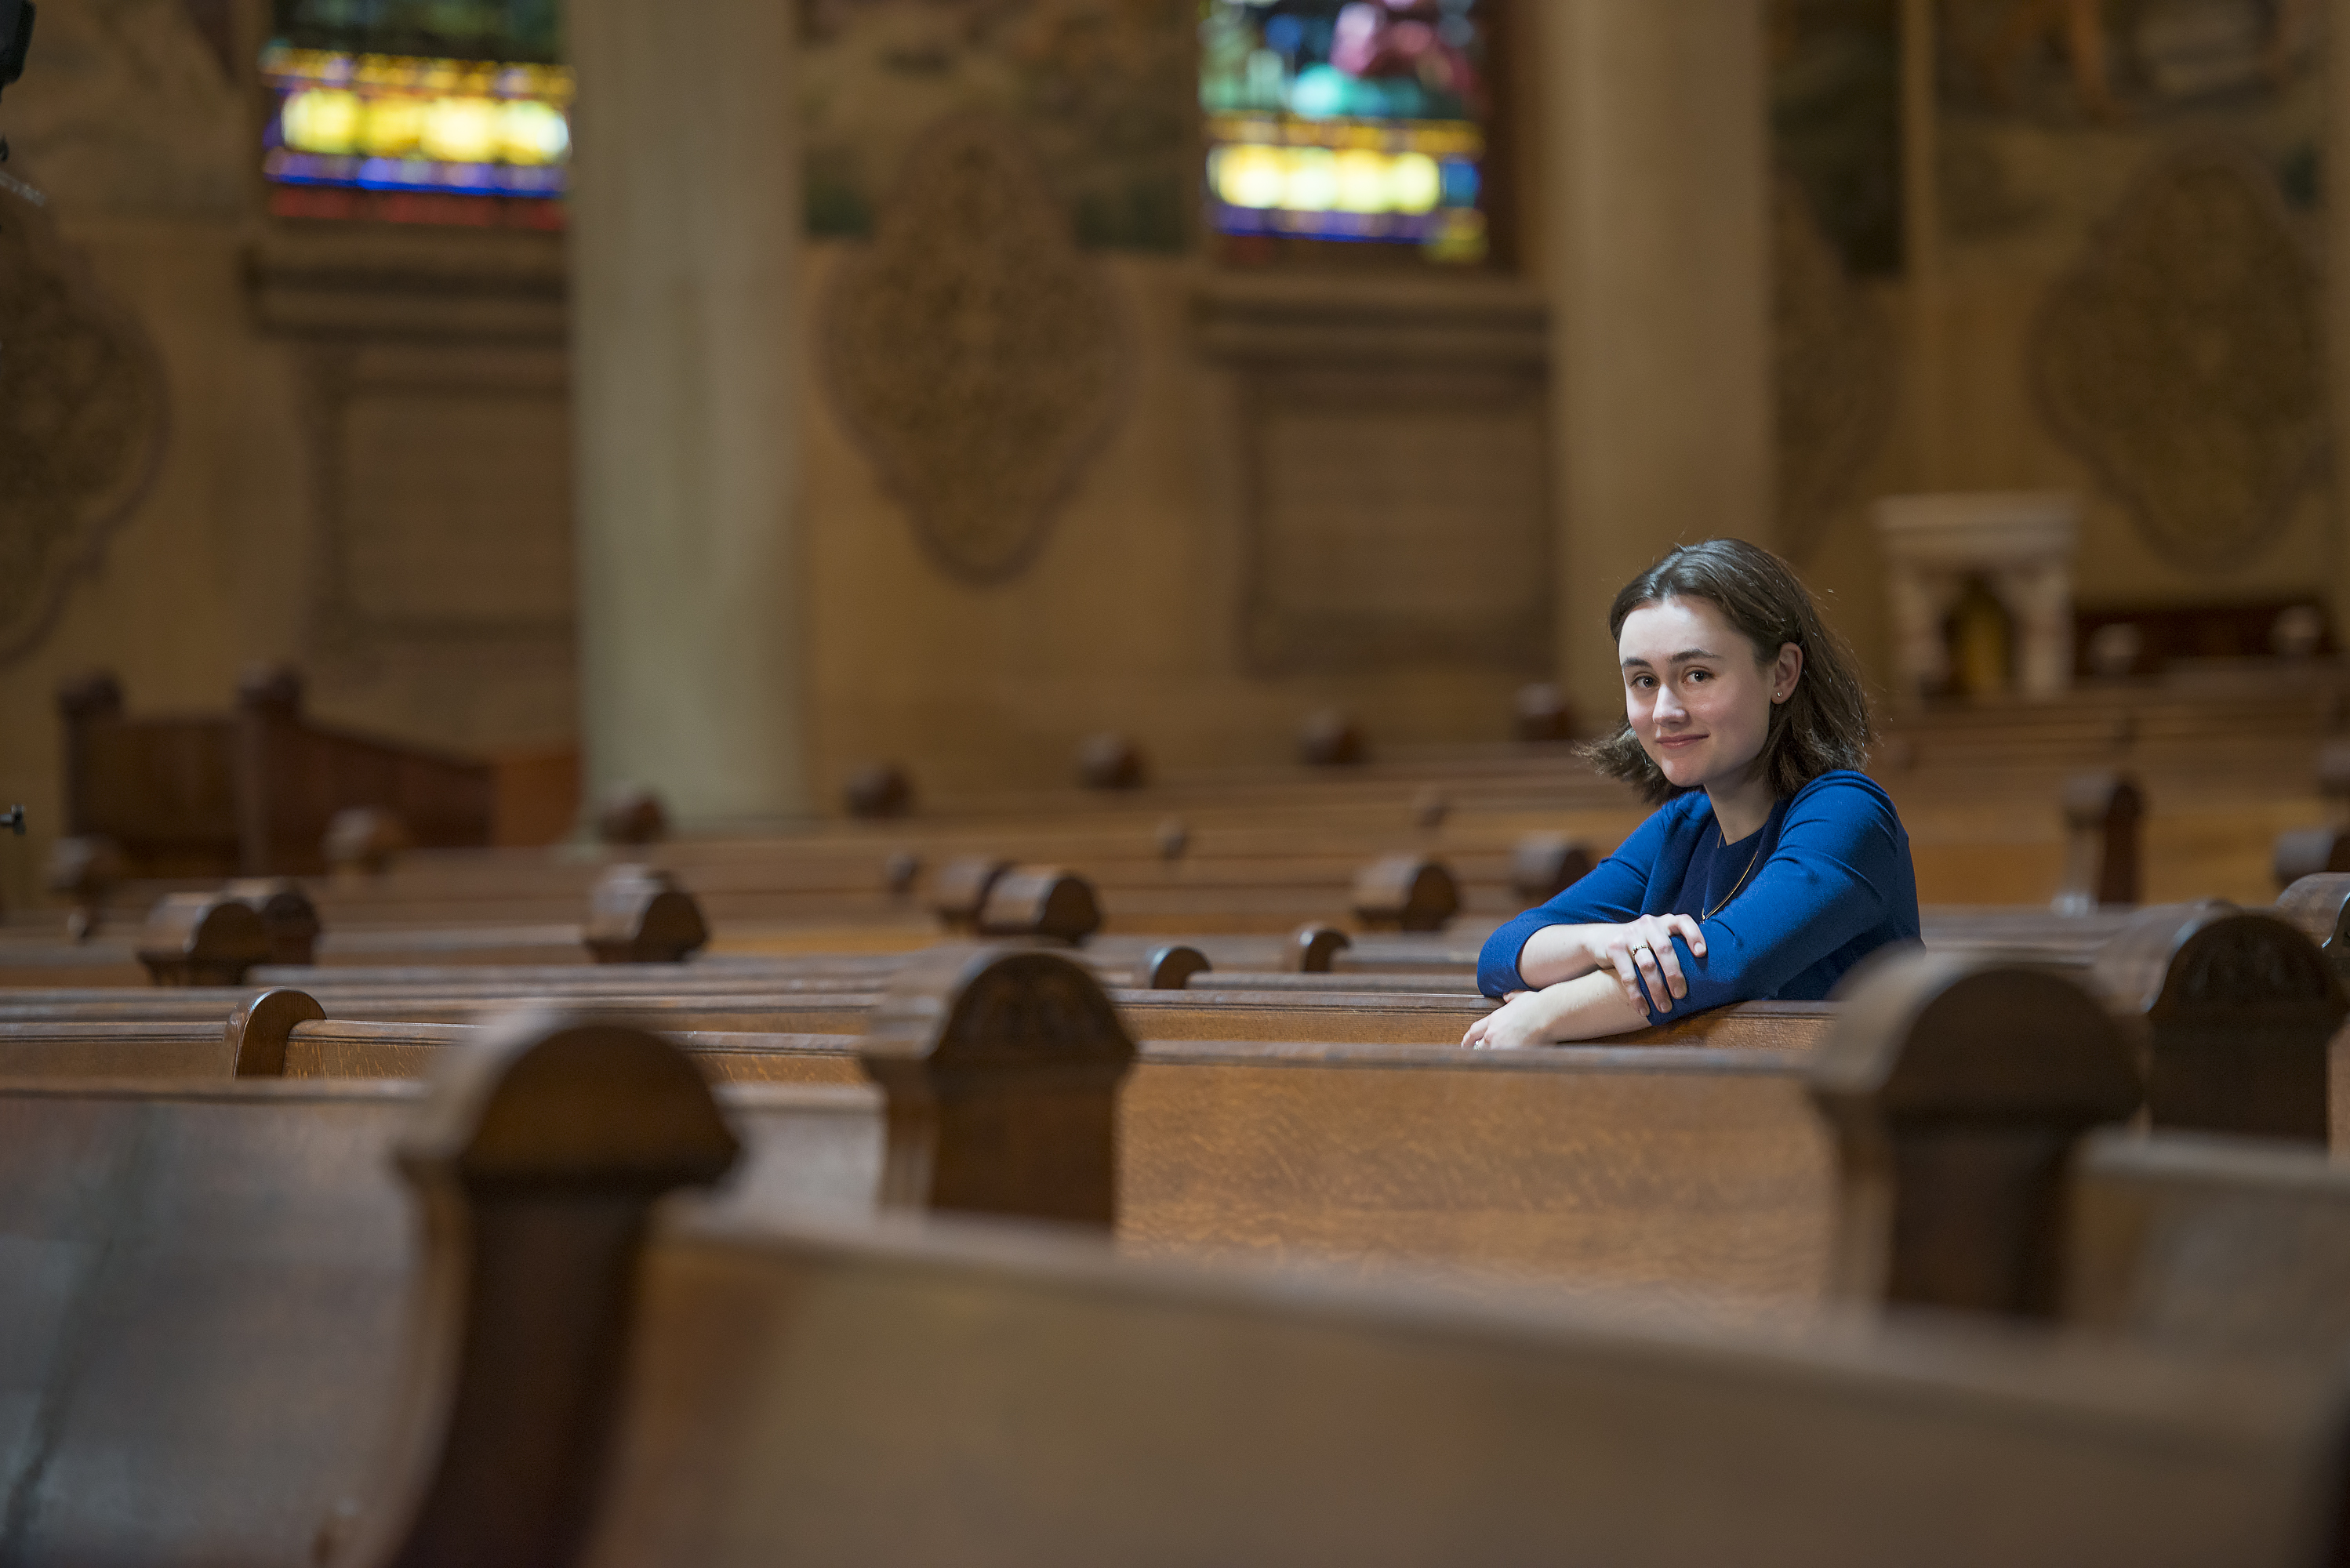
left=2091, top=902, right=2350, bottom=1142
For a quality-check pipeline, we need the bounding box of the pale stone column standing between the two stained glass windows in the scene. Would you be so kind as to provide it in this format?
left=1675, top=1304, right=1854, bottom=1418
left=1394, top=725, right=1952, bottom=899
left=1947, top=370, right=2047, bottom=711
left=566, top=0, right=811, bottom=827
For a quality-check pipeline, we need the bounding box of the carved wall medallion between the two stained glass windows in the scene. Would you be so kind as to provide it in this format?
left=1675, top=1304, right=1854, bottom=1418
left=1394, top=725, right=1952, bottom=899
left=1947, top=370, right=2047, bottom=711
left=820, top=115, right=1131, bottom=583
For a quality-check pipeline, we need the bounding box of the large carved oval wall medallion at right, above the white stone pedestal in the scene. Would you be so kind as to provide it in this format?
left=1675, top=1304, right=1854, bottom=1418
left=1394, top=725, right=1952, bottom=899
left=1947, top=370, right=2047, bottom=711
left=2030, top=151, right=2326, bottom=569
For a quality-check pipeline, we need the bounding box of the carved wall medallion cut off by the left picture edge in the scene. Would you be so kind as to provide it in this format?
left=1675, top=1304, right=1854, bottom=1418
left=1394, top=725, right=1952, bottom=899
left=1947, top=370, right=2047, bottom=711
left=0, top=188, right=167, bottom=663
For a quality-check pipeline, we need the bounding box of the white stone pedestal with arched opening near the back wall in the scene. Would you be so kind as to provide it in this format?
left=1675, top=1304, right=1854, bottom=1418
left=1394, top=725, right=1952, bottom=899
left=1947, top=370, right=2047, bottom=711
left=1876, top=492, right=2079, bottom=706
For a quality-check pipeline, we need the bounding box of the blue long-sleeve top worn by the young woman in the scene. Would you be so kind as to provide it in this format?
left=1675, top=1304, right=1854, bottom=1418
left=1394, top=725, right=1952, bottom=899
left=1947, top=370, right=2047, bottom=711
left=1476, top=769, right=1918, bottom=1020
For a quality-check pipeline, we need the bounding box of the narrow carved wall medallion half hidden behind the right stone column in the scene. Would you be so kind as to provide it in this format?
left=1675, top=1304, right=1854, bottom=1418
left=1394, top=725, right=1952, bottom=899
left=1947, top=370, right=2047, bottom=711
left=1772, top=179, right=1894, bottom=560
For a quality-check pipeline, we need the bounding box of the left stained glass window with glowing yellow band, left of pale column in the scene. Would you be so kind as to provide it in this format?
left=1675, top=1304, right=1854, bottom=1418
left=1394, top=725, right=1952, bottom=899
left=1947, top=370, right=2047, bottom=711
left=261, top=0, right=571, bottom=228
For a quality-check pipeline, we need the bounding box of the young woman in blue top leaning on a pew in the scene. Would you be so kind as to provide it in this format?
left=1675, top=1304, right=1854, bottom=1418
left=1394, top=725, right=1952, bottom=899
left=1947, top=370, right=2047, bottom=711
left=1462, top=539, right=1918, bottom=1046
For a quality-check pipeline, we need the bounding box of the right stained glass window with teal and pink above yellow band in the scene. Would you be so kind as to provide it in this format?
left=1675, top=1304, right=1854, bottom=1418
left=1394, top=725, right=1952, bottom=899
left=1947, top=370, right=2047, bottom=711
left=1198, top=0, right=1495, bottom=261
